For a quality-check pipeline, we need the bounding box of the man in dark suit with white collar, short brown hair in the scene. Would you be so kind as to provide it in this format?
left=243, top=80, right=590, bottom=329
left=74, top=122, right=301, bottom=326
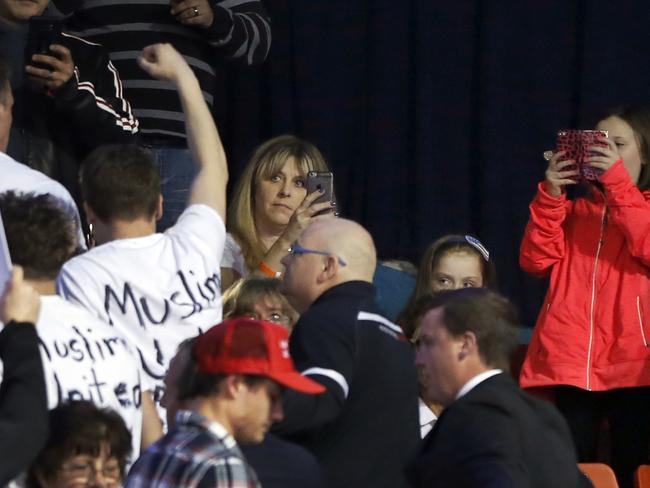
left=409, top=288, right=589, bottom=488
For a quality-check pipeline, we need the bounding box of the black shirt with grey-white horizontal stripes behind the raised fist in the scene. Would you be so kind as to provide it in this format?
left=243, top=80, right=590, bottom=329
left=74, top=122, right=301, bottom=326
left=70, top=0, right=271, bottom=140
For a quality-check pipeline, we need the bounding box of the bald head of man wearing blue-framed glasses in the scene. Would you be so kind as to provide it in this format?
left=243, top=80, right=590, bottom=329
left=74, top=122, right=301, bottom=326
left=281, top=219, right=377, bottom=313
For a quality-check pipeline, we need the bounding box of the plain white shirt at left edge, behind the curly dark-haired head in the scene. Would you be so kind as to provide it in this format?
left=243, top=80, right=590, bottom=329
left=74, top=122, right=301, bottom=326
left=0, top=152, right=86, bottom=249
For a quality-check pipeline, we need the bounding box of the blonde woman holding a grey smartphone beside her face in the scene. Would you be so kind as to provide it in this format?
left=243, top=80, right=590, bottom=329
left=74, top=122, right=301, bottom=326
left=221, top=135, right=336, bottom=291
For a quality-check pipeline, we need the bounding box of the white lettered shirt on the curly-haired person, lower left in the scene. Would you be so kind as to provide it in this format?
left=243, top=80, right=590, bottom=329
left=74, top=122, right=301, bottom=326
left=0, top=295, right=144, bottom=460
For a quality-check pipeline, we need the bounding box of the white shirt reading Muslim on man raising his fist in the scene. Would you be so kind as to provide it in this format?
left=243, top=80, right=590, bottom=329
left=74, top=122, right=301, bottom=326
left=57, top=205, right=226, bottom=403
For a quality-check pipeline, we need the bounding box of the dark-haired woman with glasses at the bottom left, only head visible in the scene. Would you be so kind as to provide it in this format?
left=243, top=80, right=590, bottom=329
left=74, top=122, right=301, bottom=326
left=26, top=401, right=131, bottom=488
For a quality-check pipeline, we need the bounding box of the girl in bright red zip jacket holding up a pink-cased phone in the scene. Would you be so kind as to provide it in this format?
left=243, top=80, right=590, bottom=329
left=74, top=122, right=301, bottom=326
left=519, top=108, right=650, bottom=486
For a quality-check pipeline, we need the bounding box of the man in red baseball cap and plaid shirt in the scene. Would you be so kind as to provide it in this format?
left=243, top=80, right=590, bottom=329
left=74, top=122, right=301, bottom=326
left=126, top=318, right=325, bottom=488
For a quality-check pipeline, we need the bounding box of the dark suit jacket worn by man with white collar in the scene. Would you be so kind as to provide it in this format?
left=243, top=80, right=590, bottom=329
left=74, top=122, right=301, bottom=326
left=409, top=374, right=590, bottom=488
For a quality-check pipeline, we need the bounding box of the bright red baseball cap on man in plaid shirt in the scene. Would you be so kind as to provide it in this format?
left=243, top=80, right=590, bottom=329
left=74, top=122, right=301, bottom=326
left=193, top=318, right=325, bottom=393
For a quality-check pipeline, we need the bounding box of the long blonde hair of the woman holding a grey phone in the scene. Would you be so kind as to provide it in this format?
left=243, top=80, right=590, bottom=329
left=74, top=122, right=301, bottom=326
left=227, top=134, right=329, bottom=270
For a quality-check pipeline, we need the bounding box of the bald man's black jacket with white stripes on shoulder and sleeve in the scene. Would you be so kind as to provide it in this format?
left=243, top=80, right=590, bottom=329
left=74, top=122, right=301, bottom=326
left=277, top=281, right=420, bottom=488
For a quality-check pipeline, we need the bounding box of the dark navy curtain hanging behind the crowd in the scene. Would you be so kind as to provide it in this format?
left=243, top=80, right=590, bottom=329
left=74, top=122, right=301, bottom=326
left=215, top=0, right=650, bottom=326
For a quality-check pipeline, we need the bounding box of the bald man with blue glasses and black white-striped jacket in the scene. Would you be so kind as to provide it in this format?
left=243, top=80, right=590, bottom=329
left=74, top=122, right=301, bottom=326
left=276, top=219, right=419, bottom=488
